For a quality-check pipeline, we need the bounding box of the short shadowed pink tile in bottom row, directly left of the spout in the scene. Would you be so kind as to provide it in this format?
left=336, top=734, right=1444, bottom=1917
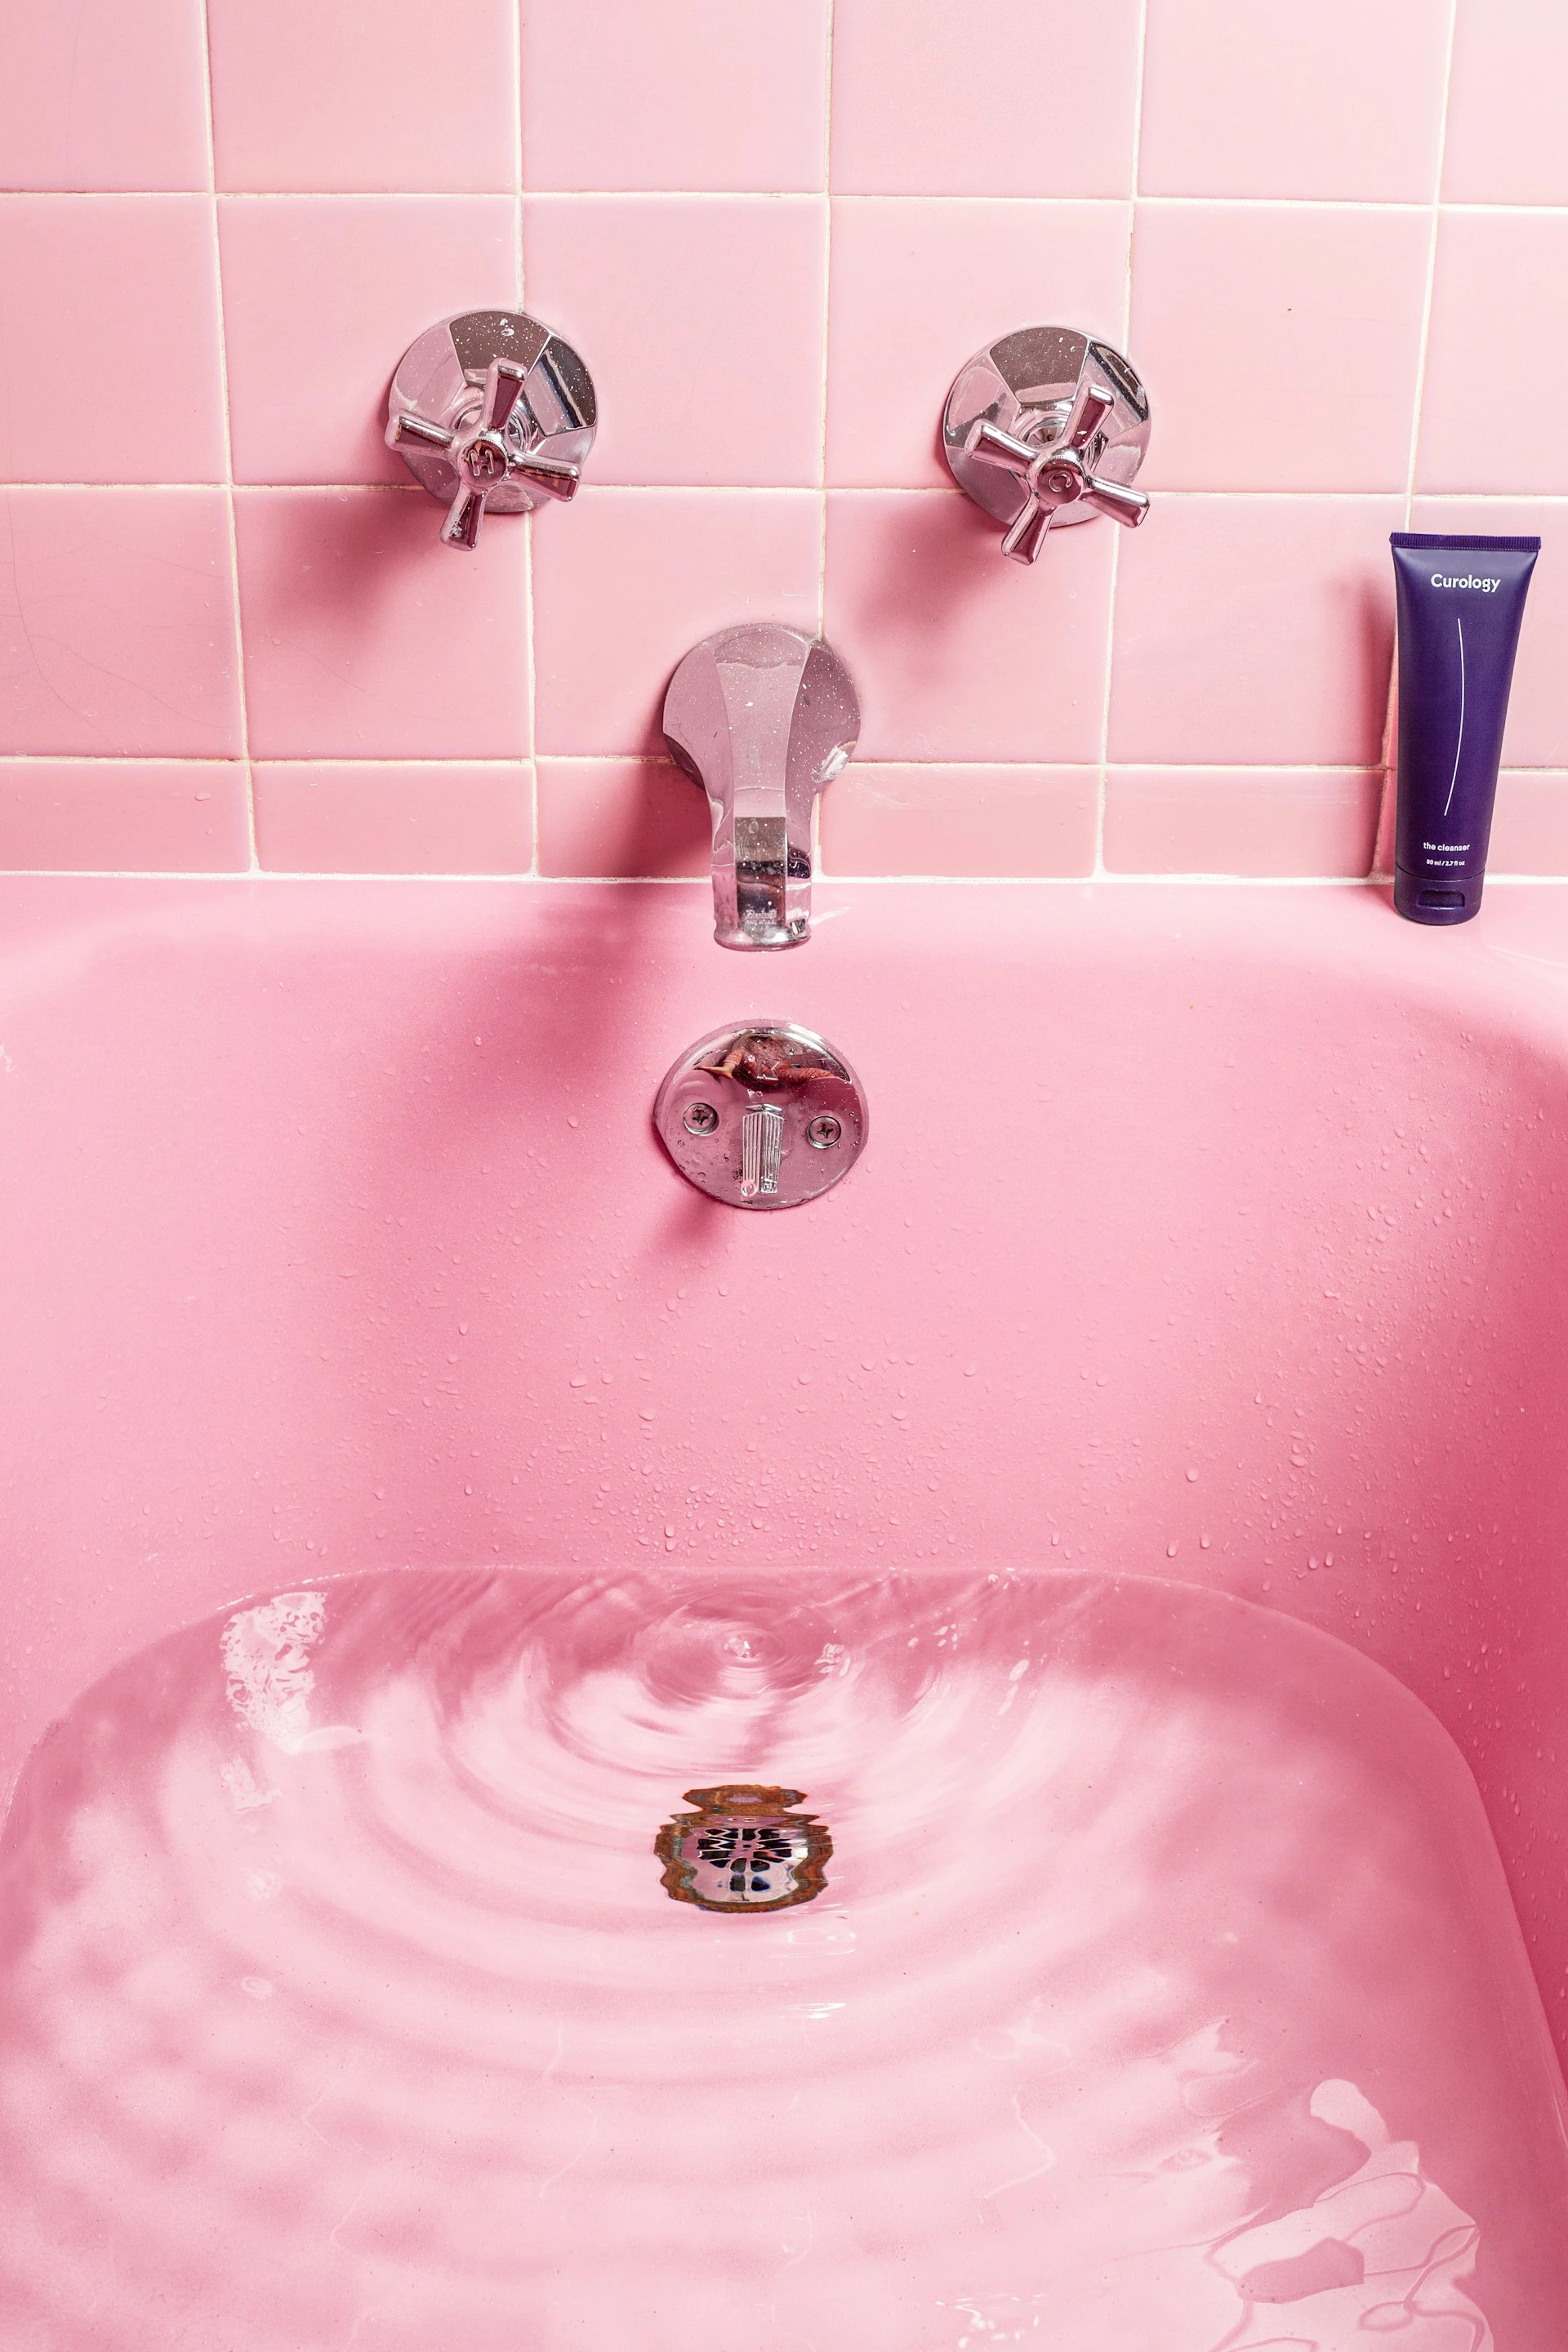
left=538, top=760, right=712, bottom=880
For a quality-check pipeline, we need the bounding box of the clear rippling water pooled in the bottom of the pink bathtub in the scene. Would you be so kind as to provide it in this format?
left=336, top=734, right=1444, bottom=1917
left=0, top=1574, right=1563, bottom=2352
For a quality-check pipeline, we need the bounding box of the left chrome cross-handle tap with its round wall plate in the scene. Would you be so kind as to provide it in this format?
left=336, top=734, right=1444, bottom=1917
left=385, top=310, right=599, bottom=548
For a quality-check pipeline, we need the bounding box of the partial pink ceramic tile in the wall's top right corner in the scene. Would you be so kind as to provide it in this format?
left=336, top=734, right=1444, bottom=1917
left=1443, top=0, right=1568, bottom=205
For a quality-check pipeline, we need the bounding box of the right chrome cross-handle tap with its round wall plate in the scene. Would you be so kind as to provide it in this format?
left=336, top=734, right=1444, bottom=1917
left=942, top=327, right=1150, bottom=564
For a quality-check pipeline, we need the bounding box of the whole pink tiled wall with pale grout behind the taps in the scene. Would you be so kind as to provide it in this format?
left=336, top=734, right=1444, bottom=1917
left=0, top=0, right=1568, bottom=880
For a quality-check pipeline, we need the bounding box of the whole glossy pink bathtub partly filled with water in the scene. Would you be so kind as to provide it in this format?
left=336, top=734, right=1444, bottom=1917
left=0, top=880, right=1568, bottom=2352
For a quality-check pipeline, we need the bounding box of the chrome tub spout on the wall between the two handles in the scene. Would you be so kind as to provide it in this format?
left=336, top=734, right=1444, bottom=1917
left=666, top=621, right=861, bottom=948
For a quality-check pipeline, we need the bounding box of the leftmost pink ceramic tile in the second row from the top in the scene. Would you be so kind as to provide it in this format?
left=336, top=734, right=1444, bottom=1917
left=0, top=195, right=223, bottom=482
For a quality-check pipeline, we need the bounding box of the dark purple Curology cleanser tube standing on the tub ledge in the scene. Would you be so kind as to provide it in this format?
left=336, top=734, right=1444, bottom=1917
left=1389, top=532, right=1539, bottom=922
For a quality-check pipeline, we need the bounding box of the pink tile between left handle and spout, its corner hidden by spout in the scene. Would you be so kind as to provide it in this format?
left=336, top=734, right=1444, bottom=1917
left=533, top=487, right=821, bottom=753
